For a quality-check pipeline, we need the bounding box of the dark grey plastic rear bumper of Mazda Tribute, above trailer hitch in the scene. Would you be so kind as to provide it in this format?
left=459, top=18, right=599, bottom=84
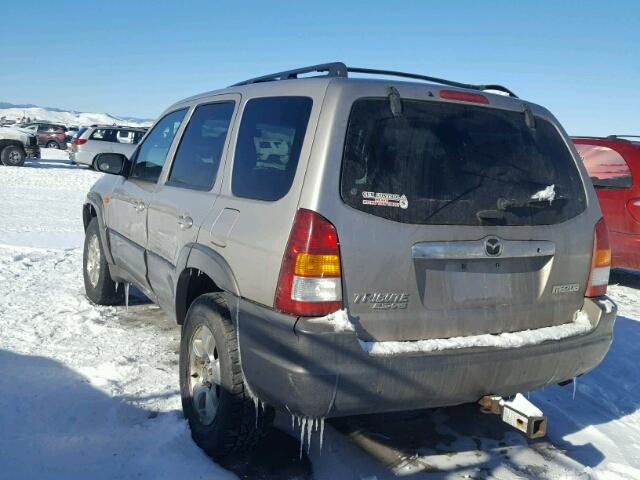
left=235, top=299, right=616, bottom=417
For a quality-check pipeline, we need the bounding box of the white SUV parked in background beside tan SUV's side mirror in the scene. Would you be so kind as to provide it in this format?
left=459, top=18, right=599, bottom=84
left=69, top=125, right=146, bottom=167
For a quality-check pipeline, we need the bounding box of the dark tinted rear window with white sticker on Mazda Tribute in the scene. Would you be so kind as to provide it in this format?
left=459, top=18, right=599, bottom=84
left=341, top=98, right=586, bottom=225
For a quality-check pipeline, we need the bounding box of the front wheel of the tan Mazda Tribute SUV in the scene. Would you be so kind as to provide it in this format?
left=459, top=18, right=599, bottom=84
left=82, top=217, right=124, bottom=305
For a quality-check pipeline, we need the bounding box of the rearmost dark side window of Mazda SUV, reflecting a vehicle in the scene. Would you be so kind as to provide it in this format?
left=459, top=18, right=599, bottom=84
left=231, top=97, right=313, bottom=201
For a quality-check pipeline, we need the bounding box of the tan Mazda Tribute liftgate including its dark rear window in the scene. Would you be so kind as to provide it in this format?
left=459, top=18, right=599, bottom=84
left=330, top=97, right=595, bottom=340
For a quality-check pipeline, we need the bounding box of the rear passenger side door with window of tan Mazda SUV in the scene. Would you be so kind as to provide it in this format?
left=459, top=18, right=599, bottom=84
left=147, top=94, right=240, bottom=308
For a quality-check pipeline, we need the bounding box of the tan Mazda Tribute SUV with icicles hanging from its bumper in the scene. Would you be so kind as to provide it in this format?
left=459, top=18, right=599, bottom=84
left=83, top=63, right=616, bottom=458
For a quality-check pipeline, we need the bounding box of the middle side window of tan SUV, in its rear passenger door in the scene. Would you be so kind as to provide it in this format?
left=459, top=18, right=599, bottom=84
left=169, top=102, right=235, bottom=190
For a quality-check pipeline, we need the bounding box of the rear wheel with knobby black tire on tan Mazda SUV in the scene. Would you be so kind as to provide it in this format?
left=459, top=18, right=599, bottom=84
left=180, top=293, right=274, bottom=461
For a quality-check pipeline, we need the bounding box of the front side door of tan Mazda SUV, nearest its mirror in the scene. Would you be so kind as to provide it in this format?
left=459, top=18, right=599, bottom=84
left=108, top=109, right=187, bottom=291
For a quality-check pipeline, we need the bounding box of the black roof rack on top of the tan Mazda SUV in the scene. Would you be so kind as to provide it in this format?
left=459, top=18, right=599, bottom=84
left=231, top=62, right=518, bottom=98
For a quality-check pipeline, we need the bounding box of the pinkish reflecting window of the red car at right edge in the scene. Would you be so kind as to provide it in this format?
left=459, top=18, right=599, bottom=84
left=576, top=144, right=633, bottom=188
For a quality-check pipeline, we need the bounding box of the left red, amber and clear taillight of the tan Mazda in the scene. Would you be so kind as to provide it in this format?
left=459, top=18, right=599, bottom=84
left=274, top=209, right=342, bottom=317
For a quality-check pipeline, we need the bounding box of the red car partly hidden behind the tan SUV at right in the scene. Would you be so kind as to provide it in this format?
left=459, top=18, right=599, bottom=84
left=573, top=135, right=640, bottom=270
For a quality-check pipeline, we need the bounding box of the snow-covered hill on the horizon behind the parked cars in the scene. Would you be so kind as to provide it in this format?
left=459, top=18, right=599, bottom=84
left=0, top=102, right=152, bottom=126
